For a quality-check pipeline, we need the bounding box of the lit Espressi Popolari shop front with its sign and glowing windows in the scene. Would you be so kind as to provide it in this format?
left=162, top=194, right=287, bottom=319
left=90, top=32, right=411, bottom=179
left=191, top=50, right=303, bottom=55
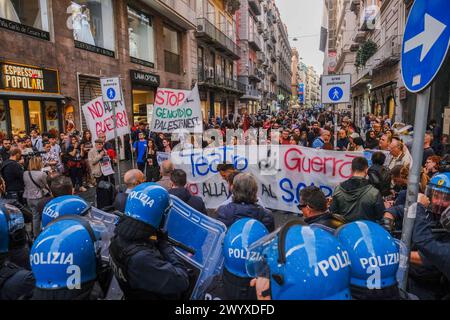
left=0, top=61, right=64, bottom=138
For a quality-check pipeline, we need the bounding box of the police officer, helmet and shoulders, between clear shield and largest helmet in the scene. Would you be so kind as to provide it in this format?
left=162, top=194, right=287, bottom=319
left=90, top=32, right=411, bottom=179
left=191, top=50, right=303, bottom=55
left=205, top=218, right=269, bottom=300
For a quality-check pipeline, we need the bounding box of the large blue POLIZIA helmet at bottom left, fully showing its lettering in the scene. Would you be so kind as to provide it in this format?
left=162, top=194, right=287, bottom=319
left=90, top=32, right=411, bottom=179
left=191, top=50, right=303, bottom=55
left=30, top=215, right=99, bottom=290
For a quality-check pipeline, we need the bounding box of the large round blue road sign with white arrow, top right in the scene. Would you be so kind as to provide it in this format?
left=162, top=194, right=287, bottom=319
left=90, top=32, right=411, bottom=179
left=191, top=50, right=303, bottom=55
left=402, top=0, right=450, bottom=92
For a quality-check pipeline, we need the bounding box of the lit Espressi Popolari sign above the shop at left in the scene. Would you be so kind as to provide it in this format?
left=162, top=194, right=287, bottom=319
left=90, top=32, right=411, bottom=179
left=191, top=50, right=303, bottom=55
left=0, top=63, right=59, bottom=93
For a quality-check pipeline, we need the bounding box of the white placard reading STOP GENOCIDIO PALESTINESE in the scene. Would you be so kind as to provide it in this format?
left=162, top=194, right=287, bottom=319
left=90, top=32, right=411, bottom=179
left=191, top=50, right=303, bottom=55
left=150, top=85, right=203, bottom=133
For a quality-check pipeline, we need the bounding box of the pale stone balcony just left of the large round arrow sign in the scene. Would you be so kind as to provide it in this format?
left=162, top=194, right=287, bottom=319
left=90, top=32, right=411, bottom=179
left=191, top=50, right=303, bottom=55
left=352, top=36, right=402, bottom=85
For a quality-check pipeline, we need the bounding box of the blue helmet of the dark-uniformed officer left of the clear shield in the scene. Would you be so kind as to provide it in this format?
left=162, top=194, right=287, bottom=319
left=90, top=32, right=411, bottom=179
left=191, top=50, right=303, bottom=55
left=125, top=182, right=171, bottom=229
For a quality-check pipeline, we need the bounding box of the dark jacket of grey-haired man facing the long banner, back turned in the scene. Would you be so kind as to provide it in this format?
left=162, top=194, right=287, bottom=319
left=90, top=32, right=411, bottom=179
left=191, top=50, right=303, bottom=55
left=217, top=202, right=275, bottom=232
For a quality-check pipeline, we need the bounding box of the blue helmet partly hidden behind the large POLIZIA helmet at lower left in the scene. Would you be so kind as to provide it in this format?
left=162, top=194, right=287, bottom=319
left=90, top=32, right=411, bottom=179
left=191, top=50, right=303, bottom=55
left=42, top=196, right=91, bottom=228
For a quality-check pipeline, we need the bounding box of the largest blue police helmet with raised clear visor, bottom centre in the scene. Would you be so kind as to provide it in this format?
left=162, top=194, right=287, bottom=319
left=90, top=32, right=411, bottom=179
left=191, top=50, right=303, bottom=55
left=246, top=220, right=351, bottom=300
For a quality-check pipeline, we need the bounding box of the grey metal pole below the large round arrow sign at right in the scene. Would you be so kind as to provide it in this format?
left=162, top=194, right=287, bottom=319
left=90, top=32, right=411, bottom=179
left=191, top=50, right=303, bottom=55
left=400, top=88, right=431, bottom=291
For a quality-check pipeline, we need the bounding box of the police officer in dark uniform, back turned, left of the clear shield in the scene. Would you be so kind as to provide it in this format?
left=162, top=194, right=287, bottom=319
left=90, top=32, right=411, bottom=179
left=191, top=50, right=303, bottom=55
left=109, top=183, right=189, bottom=300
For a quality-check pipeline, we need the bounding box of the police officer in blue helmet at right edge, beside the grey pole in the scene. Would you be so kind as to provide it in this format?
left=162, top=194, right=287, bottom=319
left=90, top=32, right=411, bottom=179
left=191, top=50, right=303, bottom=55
left=408, top=172, right=450, bottom=299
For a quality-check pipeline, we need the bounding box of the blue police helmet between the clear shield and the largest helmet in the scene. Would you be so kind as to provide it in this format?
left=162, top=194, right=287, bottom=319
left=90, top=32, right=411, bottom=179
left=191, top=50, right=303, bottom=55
left=223, top=218, right=269, bottom=278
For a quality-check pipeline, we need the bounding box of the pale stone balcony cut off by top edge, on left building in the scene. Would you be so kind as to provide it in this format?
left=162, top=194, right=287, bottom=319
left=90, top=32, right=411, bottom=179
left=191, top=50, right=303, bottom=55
left=142, top=0, right=196, bottom=30
